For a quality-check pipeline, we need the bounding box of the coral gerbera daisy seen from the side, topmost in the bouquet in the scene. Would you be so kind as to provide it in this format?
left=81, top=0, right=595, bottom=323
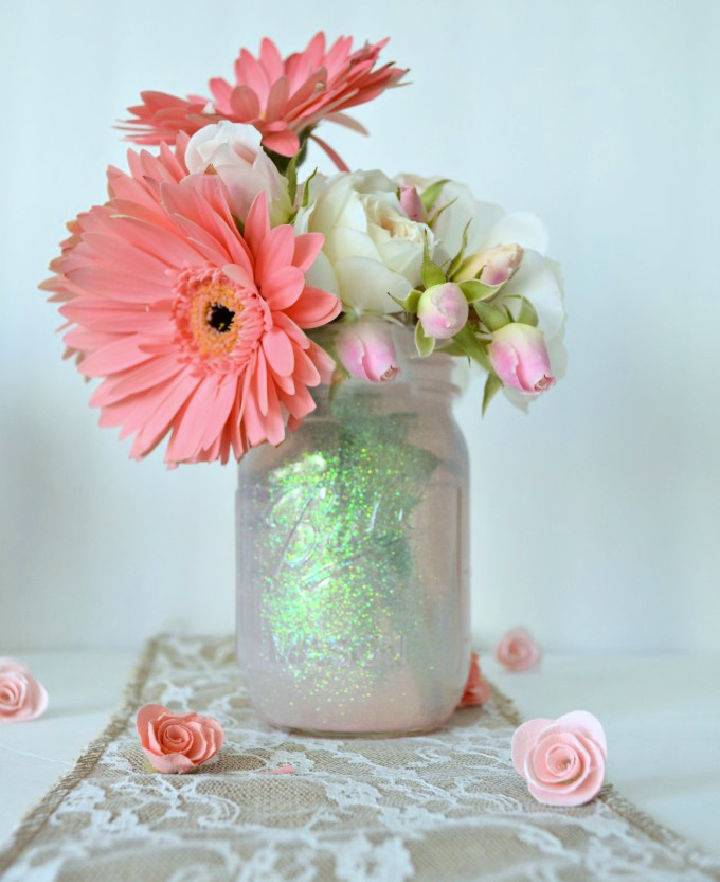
left=122, top=32, right=407, bottom=170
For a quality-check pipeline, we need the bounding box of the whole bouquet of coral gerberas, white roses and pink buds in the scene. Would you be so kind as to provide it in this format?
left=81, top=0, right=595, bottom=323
left=42, top=33, right=563, bottom=465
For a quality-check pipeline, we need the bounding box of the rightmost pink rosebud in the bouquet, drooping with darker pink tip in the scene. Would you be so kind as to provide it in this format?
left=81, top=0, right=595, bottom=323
left=488, top=322, right=555, bottom=394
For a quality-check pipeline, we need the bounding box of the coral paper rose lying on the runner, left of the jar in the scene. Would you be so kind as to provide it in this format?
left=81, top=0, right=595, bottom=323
left=137, top=704, right=223, bottom=774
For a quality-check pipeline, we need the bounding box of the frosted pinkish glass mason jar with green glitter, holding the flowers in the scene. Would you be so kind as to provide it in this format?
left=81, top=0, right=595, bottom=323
left=237, top=327, right=470, bottom=735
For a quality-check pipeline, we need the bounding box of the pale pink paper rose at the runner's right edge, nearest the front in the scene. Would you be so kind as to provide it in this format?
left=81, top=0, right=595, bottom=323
left=510, top=711, right=607, bottom=807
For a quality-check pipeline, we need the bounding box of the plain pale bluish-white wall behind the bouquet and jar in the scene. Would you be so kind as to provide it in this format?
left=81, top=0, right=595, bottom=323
left=0, top=0, right=720, bottom=654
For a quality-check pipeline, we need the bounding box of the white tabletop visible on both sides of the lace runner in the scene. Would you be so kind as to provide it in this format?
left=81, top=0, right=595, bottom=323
left=0, top=652, right=720, bottom=854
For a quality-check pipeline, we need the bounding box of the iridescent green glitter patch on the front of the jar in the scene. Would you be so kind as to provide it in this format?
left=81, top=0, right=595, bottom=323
left=261, top=394, right=437, bottom=691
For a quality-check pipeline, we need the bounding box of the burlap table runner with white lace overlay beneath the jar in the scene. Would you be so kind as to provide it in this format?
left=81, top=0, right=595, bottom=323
left=0, top=636, right=720, bottom=882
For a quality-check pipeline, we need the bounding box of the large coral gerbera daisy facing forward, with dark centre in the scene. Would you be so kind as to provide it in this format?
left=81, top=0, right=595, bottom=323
left=43, top=136, right=341, bottom=464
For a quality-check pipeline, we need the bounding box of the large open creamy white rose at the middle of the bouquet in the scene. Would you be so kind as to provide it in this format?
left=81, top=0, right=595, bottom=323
left=308, top=171, right=433, bottom=313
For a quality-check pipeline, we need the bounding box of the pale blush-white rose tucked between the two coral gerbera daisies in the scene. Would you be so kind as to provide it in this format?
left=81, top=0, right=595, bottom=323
left=185, top=120, right=290, bottom=224
